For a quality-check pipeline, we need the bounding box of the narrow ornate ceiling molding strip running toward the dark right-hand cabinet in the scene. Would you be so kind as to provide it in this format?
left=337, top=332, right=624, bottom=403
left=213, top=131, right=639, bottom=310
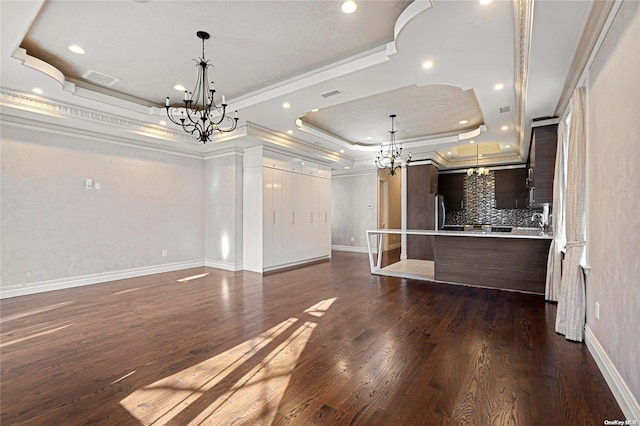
left=513, top=0, right=533, bottom=156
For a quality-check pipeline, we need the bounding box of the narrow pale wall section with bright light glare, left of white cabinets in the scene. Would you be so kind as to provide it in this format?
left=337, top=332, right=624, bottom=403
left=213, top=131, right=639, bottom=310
left=204, top=152, right=242, bottom=270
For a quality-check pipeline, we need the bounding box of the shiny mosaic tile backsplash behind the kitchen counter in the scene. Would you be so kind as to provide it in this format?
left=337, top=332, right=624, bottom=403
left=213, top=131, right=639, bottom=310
left=445, top=171, right=542, bottom=227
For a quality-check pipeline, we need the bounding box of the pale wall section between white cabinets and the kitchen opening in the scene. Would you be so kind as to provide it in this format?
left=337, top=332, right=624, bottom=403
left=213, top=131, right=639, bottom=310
left=331, top=169, right=378, bottom=252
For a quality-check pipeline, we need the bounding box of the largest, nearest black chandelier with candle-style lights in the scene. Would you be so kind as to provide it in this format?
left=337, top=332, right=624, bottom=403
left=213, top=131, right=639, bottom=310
left=165, top=31, right=238, bottom=143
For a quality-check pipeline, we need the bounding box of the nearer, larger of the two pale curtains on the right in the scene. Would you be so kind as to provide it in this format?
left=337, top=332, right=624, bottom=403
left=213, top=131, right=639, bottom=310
left=556, top=87, right=586, bottom=342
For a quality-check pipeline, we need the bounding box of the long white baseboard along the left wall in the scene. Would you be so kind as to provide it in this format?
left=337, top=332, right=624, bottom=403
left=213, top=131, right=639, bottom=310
left=0, top=260, right=205, bottom=299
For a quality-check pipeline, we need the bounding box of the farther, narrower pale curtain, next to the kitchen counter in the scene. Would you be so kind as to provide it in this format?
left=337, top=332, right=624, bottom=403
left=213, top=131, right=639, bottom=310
left=545, top=122, right=567, bottom=302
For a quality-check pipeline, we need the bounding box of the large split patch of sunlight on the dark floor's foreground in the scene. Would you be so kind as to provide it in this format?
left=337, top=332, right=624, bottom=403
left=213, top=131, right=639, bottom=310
left=120, top=297, right=336, bottom=425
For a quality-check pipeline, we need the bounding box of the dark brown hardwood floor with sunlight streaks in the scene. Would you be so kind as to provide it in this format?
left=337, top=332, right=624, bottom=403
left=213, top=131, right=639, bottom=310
left=0, top=252, right=624, bottom=426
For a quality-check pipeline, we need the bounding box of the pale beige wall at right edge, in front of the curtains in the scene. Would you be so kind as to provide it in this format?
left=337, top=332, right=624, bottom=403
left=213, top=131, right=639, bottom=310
left=587, top=1, right=640, bottom=414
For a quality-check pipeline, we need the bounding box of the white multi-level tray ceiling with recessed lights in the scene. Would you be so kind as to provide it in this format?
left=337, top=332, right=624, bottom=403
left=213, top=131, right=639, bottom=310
left=0, top=0, right=592, bottom=168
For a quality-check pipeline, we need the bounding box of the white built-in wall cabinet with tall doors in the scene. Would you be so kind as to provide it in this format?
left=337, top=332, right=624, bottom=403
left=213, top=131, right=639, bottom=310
left=243, top=147, right=331, bottom=272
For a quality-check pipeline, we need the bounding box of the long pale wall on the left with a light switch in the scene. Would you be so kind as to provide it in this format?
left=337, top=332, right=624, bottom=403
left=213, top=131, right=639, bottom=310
left=0, top=122, right=204, bottom=296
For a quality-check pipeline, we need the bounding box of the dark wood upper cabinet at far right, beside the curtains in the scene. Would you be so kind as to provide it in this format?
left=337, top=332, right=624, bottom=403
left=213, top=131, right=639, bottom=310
left=527, top=124, right=558, bottom=206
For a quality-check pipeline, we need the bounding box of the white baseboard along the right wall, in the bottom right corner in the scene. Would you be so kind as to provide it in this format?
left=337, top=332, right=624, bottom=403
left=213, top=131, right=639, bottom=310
left=584, top=325, right=640, bottom=420
